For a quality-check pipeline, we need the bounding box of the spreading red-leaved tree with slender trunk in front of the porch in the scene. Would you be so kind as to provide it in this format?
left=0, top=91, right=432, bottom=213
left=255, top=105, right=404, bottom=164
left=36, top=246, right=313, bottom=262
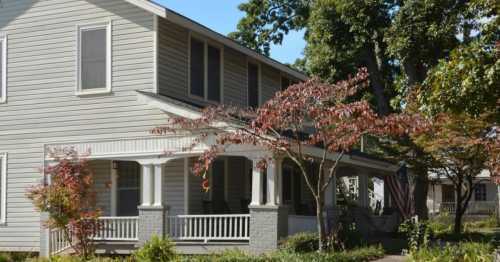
left=152, top=69, right=422, bottom=250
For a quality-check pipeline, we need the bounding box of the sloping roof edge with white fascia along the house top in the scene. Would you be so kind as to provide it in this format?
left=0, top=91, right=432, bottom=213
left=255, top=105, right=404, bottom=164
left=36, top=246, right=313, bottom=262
left=125, top=0, right=307, bottom=80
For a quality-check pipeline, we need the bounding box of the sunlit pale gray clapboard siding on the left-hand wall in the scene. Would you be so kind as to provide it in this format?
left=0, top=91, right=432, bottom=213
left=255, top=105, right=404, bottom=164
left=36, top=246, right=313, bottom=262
left=0, top=0, right=162, bottom=251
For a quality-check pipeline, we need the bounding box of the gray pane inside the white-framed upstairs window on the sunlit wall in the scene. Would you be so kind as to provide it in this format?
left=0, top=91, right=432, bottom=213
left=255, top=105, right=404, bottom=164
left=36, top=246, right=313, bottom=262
left=81, top=28, right=107, bottom=90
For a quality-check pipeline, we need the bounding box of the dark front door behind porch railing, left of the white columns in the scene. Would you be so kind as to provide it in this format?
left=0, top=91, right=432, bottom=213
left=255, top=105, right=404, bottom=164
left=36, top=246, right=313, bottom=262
left=116, top=161, right=140, bottom=216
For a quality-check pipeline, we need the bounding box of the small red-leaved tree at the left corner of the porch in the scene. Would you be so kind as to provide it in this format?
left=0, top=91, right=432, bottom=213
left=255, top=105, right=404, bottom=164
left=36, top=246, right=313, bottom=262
left=27, top=149, right=100, bottom=259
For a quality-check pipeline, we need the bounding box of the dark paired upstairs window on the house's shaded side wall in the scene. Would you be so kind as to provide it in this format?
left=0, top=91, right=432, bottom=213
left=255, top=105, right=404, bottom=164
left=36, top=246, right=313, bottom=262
left=189, top=37, right=222, bottom=102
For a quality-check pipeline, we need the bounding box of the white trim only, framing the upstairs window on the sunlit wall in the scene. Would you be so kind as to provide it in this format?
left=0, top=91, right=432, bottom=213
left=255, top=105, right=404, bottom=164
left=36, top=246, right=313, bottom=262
left=75, top=20, right=113, bottom=96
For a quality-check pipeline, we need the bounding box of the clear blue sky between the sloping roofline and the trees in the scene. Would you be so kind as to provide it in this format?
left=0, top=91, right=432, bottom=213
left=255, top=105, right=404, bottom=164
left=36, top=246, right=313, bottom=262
left=154, top=0, right=305, bottom=63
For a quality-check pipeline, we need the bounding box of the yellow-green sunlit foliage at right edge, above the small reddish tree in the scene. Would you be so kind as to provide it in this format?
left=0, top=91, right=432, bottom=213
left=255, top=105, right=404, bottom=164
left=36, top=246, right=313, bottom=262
left=419, top=18, right=500, bottom=116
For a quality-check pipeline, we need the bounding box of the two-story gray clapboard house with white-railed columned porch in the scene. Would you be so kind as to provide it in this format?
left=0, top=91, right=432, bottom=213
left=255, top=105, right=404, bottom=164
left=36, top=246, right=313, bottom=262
left=0, top=0, right=394, bottom=255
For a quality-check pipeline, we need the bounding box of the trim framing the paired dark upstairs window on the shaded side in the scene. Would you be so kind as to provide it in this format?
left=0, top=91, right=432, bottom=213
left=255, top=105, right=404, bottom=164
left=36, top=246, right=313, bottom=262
left=188, top=31, right=224, bottom=104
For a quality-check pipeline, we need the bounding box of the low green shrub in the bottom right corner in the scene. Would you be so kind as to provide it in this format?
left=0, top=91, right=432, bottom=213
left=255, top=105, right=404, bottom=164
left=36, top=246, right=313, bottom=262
left=408, top=242, right=494, bottom=262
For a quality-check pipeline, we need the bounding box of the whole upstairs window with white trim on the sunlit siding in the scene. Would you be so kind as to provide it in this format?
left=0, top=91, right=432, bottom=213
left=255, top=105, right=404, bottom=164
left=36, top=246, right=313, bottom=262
left=77, top=22, right=111, bottom=94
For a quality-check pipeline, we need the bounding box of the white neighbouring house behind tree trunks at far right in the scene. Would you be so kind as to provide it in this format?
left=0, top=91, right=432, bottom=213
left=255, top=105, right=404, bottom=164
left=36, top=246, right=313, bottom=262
left=427, top=170, right=498, bottom=216
